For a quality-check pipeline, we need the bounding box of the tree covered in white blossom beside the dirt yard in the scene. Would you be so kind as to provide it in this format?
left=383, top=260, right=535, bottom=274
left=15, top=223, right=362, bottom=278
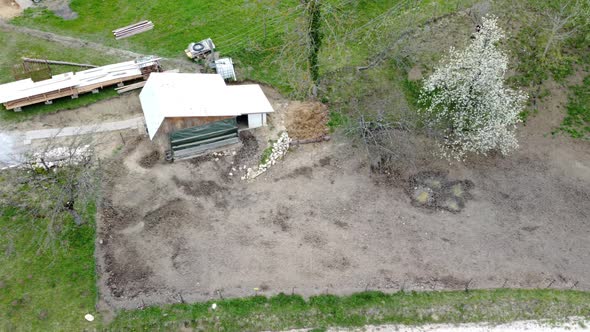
left=420, top=17, right=528, bottom=160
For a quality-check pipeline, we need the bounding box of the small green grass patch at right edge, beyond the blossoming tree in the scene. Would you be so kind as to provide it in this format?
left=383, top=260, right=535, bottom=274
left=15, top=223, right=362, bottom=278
left=559, top=76, right=590, bottom=139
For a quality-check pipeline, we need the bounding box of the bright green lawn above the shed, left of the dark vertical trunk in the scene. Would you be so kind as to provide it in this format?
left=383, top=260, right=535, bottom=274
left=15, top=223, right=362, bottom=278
left=12, top=0, right=299, bottom=88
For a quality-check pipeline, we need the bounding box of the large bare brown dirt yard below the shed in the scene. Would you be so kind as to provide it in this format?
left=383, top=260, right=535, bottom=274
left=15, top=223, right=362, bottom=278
left=97, top=81, right=590, bottom=308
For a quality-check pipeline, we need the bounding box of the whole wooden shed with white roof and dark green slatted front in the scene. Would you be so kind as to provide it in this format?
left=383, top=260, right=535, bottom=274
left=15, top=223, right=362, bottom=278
left=139, top=73, right=274, bottom=159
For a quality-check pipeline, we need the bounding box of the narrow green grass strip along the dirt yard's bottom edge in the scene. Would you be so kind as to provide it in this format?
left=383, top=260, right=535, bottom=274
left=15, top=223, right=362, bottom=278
left=109, top=289, right=590, bottom=331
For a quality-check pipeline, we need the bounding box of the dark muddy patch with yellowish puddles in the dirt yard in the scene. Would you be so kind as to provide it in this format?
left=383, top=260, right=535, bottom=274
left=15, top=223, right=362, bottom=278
left=408, top=172, right=473, bottom=213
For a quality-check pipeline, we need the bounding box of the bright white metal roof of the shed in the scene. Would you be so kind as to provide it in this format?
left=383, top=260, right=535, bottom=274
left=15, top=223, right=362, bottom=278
left=139, top=73, right=274, bottom=139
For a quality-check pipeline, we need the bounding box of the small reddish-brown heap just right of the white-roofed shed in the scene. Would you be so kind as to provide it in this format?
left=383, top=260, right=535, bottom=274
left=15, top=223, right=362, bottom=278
left=287, top=102, right=328, bottom=140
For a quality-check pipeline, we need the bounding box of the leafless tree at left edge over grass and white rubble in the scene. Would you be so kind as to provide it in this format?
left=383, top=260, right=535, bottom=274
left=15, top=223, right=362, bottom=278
left=0, top=131, right=103, bottom=247
